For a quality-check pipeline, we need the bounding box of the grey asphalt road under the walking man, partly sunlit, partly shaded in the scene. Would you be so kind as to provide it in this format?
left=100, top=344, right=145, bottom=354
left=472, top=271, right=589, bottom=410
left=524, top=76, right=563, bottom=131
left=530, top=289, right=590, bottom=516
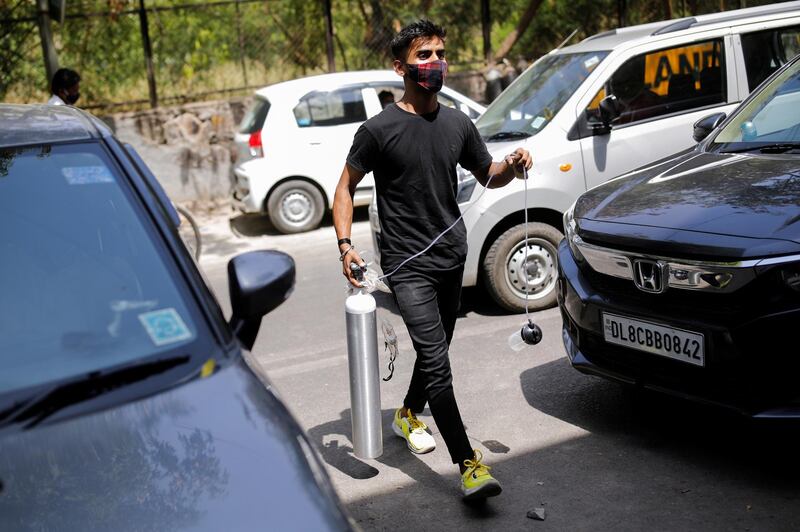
left=194, top=208, right=800, bottom=531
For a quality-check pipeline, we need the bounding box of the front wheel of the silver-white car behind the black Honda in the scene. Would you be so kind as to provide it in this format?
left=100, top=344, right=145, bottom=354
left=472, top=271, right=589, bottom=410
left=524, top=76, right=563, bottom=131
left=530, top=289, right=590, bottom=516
left=483, top=222, right=564, bottom=312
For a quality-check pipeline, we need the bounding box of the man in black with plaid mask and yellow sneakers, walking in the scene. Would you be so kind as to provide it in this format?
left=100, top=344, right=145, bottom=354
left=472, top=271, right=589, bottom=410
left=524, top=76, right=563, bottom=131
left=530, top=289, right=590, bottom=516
left=333, top=20, right=532, bottom=499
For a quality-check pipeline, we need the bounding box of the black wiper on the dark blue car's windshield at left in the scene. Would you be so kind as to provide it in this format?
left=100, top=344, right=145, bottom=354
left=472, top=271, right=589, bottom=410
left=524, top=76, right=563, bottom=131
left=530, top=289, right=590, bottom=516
left=0, top=355, right=189, bottom=428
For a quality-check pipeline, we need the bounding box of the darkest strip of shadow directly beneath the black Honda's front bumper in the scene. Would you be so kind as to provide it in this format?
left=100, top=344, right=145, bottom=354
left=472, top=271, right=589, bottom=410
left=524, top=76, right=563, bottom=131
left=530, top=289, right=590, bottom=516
left=520, top=359, right=800, bottom=486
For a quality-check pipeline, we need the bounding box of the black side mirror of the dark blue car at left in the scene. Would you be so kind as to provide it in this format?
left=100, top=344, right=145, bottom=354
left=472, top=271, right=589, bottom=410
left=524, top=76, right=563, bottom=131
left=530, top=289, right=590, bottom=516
left=228, top=251, right=295, bottom=349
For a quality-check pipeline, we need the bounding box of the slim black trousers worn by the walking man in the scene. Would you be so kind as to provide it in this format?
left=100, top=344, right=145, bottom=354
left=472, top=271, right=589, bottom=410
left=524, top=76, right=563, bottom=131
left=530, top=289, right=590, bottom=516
left=388, top=266, right=473, bottom=464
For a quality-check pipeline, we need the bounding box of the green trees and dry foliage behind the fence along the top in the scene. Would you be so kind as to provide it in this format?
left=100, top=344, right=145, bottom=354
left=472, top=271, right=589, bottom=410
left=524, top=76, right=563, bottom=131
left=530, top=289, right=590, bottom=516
left=0, top=0, right=788, bottom=105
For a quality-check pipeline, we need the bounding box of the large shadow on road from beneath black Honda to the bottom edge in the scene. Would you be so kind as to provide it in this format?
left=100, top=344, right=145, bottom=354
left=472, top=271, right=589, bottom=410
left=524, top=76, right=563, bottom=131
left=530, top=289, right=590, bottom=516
left=336, top=359, right=800, bottom=530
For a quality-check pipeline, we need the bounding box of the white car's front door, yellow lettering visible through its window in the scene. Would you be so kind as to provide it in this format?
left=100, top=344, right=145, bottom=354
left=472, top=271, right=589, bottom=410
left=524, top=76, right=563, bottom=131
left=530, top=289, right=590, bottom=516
left=579, top=30, right=738, bottom=188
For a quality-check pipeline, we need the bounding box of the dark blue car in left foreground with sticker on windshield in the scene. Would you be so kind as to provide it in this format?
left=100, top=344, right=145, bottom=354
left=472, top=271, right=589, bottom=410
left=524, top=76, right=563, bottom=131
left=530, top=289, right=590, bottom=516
left=0, top=105, right=350, bottom=531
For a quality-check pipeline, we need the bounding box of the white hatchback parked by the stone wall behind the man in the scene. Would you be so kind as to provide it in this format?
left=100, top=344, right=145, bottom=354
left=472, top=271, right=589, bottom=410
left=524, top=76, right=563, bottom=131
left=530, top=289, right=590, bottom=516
left=228, top=70, right=485, bottom=233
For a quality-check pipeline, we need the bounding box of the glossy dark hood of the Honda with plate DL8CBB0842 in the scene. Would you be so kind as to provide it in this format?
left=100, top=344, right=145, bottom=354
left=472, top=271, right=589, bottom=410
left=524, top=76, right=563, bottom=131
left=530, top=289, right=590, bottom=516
left=574, top=151, right=800, bottom=258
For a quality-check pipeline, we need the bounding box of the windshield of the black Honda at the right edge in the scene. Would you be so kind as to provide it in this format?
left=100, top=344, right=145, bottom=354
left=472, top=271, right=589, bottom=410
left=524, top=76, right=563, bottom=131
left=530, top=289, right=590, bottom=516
left=710, top=61, right=800, bottom=152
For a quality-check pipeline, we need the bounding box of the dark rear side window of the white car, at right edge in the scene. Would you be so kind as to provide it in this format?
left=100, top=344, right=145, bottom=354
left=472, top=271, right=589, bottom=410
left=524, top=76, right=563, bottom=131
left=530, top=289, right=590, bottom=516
left=742, top=26, right=800, bottom=91
